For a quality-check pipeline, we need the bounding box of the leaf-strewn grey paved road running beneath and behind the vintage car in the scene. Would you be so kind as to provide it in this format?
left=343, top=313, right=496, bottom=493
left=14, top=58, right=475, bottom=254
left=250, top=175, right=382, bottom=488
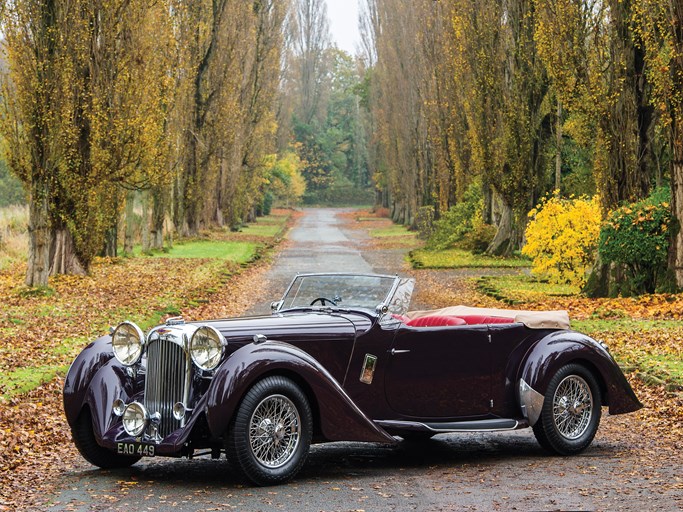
left=50, top=209, right=683, bottom=512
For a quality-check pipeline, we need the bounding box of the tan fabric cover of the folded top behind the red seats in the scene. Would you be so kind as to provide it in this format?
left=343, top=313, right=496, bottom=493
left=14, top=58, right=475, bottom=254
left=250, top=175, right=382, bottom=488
left=406, top=306, right=569, bottom=329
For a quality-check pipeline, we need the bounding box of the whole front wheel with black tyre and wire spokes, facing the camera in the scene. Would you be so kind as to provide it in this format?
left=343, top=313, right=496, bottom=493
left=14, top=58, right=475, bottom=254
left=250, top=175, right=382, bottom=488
left=226, top=376, right=313, bottom=485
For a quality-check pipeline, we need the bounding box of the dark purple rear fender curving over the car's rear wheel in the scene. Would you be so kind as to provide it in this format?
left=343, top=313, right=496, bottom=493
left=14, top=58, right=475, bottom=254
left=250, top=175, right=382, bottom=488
left=517, top=331, right=642, bottom=414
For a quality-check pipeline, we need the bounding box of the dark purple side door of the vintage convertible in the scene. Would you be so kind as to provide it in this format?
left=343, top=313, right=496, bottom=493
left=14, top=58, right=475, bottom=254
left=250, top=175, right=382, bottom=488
left=385, top=325, right=491, bottom=420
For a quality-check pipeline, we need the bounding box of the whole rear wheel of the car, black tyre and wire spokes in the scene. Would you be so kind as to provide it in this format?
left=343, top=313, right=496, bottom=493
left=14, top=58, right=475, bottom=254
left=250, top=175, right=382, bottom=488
left=533, top=364, right=602, bottom=455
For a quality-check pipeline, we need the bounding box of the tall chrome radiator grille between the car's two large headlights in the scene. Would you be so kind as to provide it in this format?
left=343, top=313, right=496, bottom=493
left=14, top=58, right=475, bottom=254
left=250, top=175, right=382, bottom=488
left=144, top=339, right=190, bottom=438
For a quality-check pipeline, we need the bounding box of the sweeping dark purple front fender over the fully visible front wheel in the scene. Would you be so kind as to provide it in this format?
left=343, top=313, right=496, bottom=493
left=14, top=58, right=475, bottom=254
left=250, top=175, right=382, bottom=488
left=206, top=341, right=396, bottom=444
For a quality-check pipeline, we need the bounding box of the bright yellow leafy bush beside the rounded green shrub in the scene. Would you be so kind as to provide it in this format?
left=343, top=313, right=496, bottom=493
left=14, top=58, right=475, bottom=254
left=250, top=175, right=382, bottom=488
left=522, top=194, right=601, bottom=286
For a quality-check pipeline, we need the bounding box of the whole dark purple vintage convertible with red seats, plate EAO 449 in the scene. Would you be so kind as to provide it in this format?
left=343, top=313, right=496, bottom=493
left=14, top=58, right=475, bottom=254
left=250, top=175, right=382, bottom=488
left=64, top=274, right=641, bottom=485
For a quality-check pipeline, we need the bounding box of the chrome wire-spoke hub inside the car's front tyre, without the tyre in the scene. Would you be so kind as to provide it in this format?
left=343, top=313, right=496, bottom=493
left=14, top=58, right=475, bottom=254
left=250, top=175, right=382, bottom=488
left=249, top=395, right=301, bottom=468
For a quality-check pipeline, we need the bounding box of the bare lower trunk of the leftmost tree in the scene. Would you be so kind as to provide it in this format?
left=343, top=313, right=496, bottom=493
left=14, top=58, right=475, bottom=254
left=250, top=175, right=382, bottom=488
left=26, top=176, right=51, bottom=286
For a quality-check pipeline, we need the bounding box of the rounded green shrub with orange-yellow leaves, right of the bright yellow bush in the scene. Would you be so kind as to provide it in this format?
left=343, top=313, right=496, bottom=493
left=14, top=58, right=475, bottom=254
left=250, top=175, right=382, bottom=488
left=598, top=187, right=677, bottom=294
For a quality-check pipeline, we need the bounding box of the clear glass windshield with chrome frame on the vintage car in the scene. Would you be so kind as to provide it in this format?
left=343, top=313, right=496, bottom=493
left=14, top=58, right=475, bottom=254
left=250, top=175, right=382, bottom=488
left=279, top=274, right=412, bottom=312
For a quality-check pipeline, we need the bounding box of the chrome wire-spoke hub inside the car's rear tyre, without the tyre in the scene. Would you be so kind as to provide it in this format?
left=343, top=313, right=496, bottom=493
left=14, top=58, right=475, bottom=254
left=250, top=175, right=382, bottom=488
left=553, top=375, right=593, bottom=439
